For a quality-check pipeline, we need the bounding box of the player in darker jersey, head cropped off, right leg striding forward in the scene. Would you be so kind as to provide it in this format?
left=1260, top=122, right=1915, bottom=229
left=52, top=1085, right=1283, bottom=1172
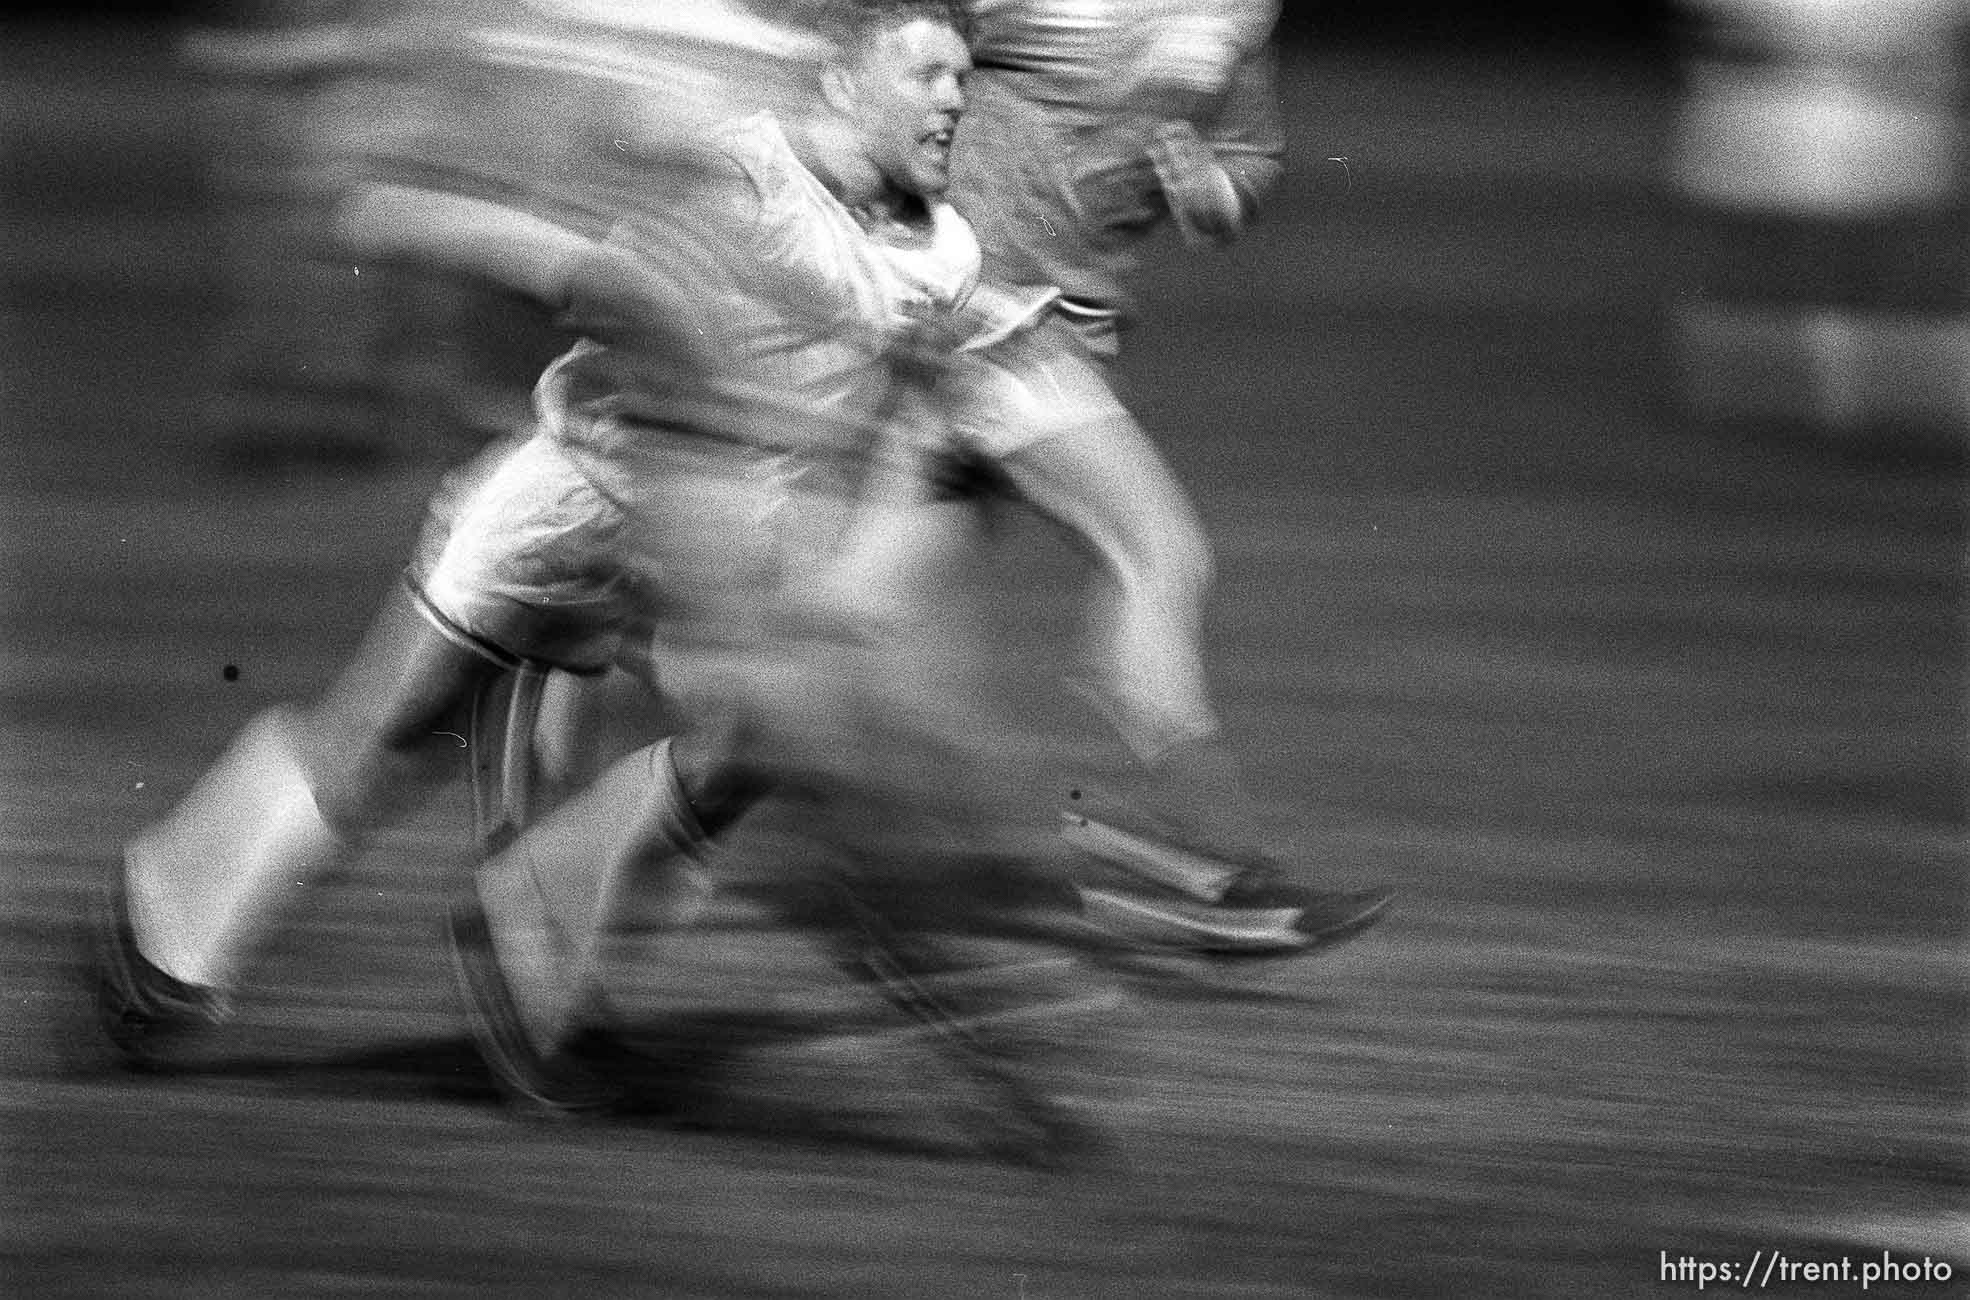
left=863, top=0, right=1391, bottom=953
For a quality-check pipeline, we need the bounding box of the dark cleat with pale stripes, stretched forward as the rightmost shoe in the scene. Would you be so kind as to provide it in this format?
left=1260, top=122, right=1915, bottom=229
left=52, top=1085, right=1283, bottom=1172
left=1062, top=813, right=1395, bottom=957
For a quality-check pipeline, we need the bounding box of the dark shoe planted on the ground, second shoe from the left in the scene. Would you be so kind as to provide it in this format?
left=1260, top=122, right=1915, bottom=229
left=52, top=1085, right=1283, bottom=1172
left=447, top=900, right=628, bottom=1119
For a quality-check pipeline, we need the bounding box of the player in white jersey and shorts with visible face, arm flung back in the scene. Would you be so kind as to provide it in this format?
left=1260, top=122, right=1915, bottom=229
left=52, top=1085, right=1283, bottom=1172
left=99, top=4, right=977, bottom=1062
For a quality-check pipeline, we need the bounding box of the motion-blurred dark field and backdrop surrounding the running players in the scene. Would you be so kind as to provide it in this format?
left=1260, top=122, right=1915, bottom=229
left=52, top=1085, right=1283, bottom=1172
left=0, top=0, right=1970, bottom=1298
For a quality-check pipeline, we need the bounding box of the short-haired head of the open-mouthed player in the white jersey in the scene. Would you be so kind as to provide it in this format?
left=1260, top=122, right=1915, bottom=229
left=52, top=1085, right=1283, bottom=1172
left=849, top=18, right=971, bottom=197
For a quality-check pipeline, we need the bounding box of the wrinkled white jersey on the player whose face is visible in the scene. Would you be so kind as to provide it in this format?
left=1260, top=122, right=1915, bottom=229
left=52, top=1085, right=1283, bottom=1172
left=536, top=114, right=979, bottom=498
